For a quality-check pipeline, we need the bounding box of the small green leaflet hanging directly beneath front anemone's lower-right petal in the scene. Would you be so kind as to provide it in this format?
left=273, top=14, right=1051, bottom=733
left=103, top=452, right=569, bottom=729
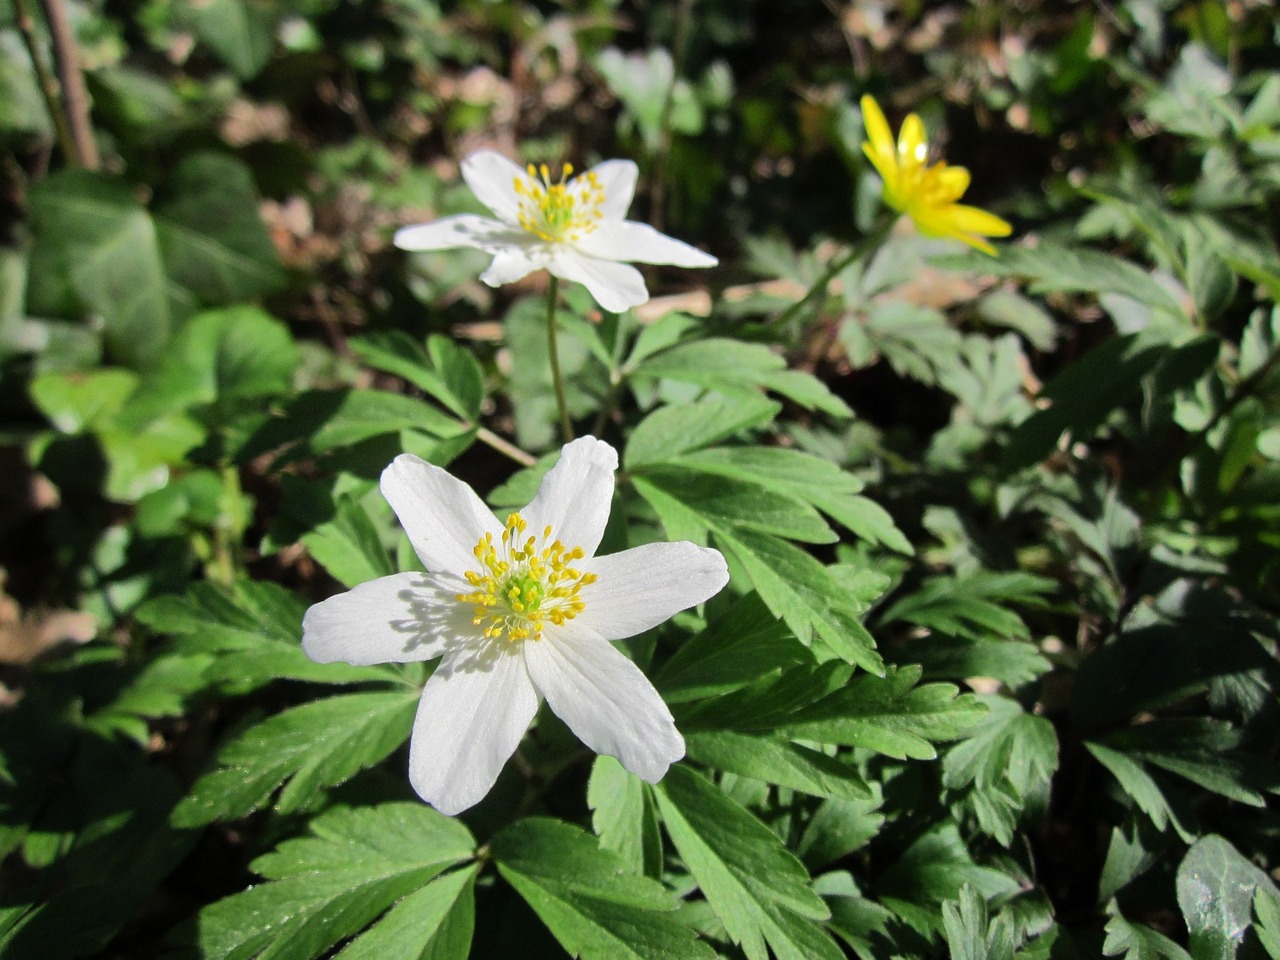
left=586, top=754, right=662, bottom=878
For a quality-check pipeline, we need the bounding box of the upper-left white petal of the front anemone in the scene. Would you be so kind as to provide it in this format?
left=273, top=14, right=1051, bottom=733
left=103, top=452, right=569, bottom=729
left=381, top=453, right=502, bottom=577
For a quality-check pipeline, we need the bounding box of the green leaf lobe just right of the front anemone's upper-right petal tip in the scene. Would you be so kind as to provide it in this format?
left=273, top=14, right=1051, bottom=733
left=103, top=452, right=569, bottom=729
left=623, top=394, right=782, bottom=470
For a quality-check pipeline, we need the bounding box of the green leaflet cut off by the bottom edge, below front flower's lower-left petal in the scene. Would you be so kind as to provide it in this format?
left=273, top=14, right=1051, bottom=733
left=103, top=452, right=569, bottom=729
left=338, top=865, right=480, bottom=960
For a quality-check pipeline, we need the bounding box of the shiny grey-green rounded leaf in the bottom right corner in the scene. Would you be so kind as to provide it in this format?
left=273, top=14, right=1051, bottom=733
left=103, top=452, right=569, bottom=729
left=1178, top=835, right=1280, bottom=960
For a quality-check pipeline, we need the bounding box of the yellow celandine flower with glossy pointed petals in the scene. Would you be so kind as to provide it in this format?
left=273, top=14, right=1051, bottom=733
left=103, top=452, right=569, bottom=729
left=861, top=96, right=1014, bottom=256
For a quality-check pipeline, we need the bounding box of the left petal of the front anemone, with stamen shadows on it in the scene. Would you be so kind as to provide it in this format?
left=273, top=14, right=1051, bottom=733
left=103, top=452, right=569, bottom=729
left=302, top=573, right=475, bottom=664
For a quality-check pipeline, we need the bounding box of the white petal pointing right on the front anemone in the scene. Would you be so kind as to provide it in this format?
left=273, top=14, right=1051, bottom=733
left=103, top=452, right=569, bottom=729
left=573, top=540, right=728, bottom=640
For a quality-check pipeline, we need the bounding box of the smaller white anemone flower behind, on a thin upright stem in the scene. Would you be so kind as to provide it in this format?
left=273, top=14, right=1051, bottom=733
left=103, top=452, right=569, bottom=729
left=396, top=150, right=717, bottom=312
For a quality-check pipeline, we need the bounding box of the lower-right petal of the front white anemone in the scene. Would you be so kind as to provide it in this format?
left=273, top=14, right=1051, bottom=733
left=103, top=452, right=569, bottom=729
left=525, top=621, right=685, bottom=783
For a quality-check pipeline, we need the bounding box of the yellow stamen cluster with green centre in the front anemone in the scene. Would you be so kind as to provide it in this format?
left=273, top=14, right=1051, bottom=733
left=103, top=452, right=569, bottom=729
left=457, top=513, right=596, bottom=643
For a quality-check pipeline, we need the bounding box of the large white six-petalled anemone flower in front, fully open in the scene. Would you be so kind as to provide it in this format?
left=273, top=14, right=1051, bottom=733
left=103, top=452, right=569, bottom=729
left=294, top=436, right=728, bottom=814
